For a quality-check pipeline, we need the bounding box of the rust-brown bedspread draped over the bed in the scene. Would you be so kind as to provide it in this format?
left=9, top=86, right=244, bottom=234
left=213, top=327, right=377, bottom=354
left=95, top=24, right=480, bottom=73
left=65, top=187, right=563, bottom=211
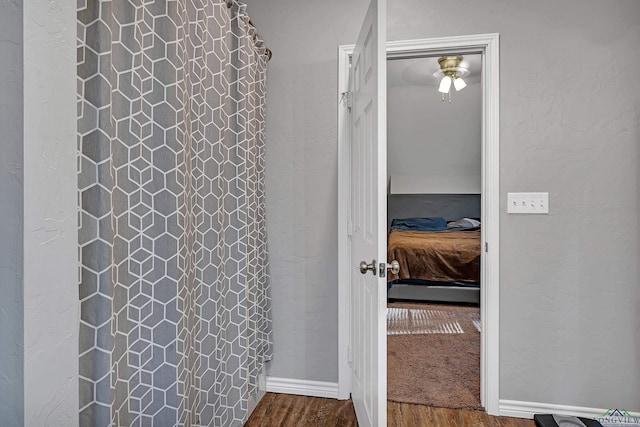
left=387, top=227, right=480, bottom=282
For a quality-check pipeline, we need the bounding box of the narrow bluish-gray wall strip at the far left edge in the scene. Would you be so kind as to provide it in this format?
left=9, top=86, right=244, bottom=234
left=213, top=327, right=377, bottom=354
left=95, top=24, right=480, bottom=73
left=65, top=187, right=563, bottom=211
left=0, top=0, right=24, bottom=427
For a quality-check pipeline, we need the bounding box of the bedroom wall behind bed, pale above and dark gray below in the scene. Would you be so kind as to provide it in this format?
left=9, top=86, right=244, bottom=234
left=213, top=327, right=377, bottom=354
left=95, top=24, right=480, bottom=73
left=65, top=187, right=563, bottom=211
left=387, top=69, right=482, bottom=229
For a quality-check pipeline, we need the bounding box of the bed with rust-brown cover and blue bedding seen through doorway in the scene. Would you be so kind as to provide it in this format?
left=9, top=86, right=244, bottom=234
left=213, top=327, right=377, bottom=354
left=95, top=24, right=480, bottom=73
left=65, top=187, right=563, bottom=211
left=387, top=218, right=480, bottom=303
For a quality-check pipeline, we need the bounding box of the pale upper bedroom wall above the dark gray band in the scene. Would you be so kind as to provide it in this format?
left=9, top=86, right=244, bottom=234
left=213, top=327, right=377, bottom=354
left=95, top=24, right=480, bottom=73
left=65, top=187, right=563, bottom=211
left=387, top=59, right=482, bottom=193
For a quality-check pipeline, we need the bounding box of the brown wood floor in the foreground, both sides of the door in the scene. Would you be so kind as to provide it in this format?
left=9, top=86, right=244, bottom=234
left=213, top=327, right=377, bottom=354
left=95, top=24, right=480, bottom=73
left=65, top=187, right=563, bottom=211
left=245, top=393, right=535, bottom=427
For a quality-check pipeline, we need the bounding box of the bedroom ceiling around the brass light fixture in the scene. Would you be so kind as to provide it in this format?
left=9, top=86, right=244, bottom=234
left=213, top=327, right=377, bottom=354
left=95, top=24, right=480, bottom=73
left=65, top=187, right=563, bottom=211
left=387, top=54, right=482, bottom=89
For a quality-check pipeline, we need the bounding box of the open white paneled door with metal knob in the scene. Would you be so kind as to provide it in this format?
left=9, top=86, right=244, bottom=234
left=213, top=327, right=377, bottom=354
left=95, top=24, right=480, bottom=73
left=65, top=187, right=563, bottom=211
left=350, top=0, right=387, bottom=427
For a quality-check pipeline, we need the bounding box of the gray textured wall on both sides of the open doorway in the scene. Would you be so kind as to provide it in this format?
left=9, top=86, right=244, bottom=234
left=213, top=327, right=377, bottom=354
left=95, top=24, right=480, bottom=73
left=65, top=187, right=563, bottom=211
left=247, top=0, right=640, bottom=411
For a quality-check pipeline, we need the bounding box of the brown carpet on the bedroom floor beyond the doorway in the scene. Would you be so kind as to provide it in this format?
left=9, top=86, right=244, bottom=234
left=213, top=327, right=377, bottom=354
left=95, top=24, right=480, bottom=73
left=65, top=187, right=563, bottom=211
left=387, top=303, right=483, bottom=410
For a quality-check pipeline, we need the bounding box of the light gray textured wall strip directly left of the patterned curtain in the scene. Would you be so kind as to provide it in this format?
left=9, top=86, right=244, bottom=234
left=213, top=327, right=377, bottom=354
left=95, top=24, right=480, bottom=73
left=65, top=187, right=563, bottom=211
left=24, top=0, right=79, bottom=427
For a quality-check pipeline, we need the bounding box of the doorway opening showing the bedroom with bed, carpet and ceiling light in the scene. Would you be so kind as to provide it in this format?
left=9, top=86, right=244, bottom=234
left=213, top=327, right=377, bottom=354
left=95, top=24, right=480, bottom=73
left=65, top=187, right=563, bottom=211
left=386, top=51, right=482, bottom=410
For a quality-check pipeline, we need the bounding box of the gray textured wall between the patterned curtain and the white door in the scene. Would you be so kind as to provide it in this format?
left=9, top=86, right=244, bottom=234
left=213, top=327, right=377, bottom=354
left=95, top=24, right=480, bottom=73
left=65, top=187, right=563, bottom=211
left=240, top=0, right=367, bottom=381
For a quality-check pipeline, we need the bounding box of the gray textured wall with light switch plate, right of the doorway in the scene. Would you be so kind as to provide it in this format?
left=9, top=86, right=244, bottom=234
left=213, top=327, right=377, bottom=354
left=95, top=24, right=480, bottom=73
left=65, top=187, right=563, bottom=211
left=388, top=1, right=640, bottom=410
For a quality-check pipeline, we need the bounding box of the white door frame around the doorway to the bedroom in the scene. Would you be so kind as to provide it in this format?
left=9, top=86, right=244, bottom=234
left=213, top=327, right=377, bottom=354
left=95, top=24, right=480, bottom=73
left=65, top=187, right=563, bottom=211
left=338, top=34, right=500, bottom=415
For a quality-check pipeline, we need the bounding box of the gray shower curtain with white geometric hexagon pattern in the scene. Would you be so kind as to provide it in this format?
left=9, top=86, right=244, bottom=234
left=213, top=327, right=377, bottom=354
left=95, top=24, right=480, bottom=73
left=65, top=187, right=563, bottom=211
left=77, top=0, right=271, bottom=427
